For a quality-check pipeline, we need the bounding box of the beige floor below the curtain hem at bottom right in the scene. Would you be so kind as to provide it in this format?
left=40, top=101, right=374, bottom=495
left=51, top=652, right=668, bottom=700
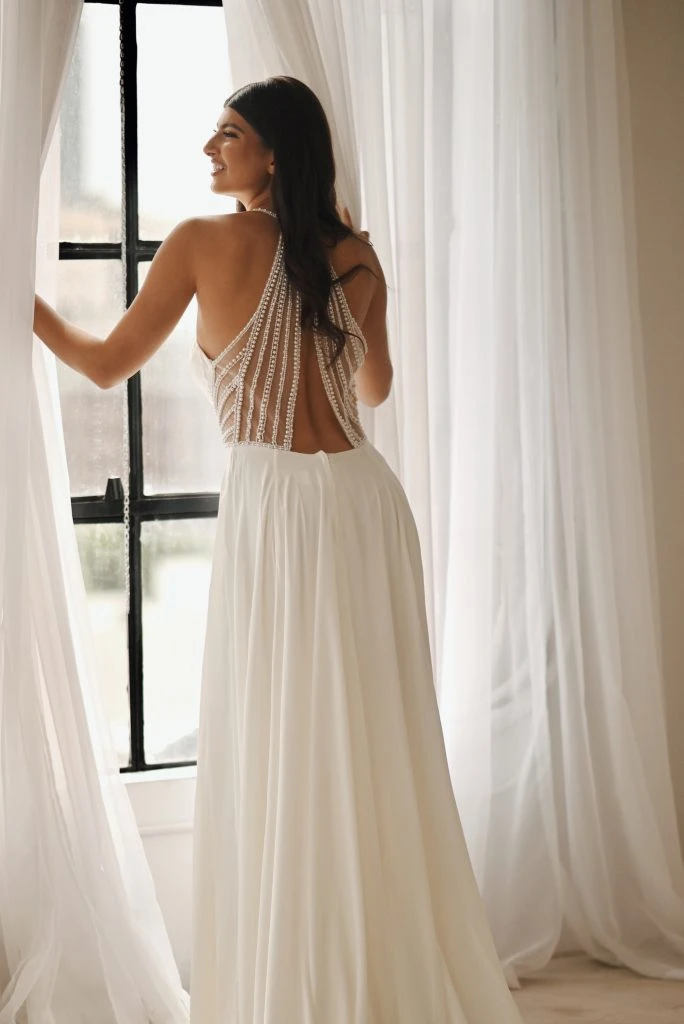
left=514, top=956, right=684, bottom=1024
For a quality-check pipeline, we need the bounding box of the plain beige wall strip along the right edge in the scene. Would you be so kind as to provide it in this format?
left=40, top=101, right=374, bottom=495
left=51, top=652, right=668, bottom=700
left=623, top=0, right=684, bottom=839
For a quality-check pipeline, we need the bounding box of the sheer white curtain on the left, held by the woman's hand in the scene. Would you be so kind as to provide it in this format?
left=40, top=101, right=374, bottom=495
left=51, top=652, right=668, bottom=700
left=0, top=0, right=188, bottom=1024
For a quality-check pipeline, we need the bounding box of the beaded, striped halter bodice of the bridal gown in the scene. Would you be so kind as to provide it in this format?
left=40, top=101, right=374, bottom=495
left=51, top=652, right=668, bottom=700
left=193, top=210, right=368, bottom=451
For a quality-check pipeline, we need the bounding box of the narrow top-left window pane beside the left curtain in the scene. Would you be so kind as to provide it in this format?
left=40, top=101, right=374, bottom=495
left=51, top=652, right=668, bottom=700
left=59, top=3, right=121, bottom=242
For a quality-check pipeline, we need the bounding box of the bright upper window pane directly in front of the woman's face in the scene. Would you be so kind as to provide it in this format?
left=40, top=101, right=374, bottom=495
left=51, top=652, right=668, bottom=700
left=137, top=4, right=231, bottom=240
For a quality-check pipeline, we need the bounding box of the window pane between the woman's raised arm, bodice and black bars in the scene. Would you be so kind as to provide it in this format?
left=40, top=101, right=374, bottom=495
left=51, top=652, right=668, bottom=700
left=138, top=263, right=225, bottom=495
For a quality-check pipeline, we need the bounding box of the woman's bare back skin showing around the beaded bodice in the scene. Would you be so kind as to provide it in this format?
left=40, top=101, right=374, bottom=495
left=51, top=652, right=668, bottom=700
left=196, top=212, right=378, bottom=453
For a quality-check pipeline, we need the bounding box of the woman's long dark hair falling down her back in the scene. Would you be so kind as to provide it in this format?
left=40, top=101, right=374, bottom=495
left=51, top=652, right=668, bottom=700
left=223, top=75, right=377, bottom=366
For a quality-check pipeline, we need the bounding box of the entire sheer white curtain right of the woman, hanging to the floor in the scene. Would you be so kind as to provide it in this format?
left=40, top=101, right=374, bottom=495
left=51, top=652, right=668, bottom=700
left=224, top=0, right=684, bottom=979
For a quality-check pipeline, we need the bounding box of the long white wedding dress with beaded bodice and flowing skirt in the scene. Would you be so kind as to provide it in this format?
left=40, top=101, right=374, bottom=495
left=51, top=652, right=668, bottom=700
left=190, top=209, right=520, bottom=1024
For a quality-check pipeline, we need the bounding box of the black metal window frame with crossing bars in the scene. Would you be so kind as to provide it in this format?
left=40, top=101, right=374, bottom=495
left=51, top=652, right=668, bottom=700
left=64, top=0, right=222, bottom=772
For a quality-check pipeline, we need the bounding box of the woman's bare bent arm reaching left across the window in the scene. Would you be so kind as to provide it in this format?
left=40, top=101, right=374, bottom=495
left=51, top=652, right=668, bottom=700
left=34, top=219, right=199, bottom=388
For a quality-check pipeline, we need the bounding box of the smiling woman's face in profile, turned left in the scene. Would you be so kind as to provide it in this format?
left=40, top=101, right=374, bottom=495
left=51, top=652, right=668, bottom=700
left=204, top=106, right=274, bottom=201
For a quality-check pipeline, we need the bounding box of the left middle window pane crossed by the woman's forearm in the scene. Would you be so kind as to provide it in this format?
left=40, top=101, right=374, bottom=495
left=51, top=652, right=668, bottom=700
left=56, top=260, right=126, bottom=497
